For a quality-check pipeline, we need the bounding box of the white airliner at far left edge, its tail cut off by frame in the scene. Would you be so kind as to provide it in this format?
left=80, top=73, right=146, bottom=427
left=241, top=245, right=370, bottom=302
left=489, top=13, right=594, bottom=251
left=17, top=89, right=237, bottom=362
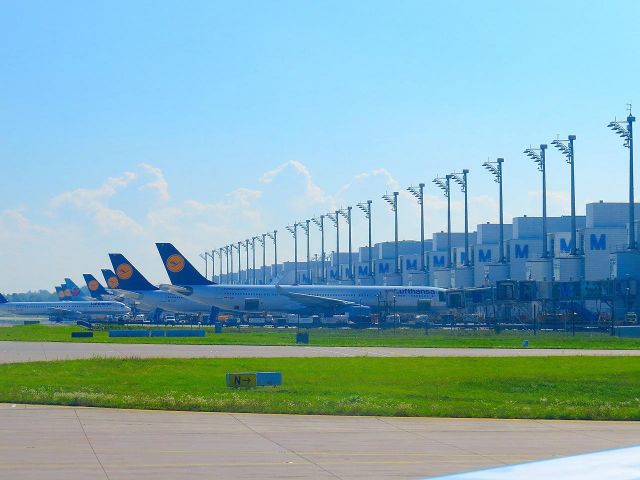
left=0, top=294, right=131, bottom=321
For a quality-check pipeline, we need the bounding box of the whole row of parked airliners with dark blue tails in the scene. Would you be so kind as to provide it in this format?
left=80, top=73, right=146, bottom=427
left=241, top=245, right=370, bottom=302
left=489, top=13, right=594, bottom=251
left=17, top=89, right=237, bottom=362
left=0, top=243, right=446, bottom=318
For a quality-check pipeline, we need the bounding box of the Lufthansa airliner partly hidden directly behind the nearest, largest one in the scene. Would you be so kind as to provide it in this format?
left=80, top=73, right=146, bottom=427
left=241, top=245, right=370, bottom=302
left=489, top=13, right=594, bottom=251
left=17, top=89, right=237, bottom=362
left=103, top=253, right=211, bottom=314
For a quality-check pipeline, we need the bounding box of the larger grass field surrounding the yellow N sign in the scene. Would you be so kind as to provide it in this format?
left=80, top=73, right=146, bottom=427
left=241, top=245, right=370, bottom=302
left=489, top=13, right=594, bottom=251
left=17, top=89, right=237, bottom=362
left=0, top=357, right=640, bottom=420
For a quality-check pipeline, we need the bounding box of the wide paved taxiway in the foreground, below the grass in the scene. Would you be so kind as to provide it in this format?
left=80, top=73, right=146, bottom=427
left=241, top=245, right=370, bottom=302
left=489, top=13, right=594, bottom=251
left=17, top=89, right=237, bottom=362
left=0, top=404, right=640, bottom=480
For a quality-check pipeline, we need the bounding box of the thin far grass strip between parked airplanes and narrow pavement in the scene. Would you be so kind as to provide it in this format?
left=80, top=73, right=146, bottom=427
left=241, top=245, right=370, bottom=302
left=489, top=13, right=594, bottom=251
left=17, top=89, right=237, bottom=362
left=0, top=325, right=640, bottom=349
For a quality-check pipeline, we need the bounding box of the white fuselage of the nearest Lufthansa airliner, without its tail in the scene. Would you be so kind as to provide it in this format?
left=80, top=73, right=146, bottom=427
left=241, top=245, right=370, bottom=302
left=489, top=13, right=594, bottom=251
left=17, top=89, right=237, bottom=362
left=172, top=285, right=446, bottom=313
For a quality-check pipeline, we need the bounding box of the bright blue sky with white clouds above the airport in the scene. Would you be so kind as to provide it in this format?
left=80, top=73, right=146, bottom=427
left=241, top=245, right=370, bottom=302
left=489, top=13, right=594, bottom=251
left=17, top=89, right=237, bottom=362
left=0, top=1, right=640, bottom=292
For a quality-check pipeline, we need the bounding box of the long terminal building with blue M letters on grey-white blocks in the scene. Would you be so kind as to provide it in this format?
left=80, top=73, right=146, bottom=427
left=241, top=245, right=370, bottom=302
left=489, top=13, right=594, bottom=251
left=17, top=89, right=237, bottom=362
left=214, top=201, right=640, bottom=316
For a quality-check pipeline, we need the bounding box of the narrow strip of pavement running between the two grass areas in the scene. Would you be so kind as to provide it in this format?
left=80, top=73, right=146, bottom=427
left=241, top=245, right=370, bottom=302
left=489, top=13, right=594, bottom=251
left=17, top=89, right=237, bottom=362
left=0, top=341, right=640, bottom=363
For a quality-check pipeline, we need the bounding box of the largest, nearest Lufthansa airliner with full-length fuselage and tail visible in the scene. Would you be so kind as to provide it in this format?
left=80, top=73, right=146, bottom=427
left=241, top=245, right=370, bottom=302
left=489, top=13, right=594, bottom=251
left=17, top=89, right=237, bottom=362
left=156, top=243, right=446, bottom=318
